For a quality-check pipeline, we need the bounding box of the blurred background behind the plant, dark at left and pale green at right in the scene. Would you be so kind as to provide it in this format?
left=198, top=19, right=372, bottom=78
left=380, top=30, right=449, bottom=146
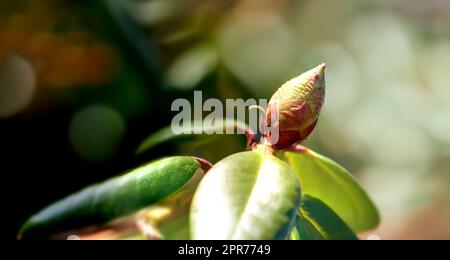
left=0, top=0, right=450, bottom=239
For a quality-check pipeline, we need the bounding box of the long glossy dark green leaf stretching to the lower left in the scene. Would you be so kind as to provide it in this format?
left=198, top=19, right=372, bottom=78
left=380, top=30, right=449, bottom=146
left=19, top=156, right=200, bottom=238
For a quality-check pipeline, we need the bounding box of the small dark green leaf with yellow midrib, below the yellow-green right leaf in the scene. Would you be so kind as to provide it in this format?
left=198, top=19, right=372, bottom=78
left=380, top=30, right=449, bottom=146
left=291, top=195, right=358, bottom=240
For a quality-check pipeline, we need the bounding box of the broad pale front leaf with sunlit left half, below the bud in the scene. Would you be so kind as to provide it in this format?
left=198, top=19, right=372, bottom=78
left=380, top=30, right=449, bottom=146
left=191, top=151, right=300, bottom=240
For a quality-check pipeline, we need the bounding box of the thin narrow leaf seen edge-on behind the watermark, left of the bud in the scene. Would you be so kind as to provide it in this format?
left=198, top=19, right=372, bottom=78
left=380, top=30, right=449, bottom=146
left=136, top=120, right=248, bottom=154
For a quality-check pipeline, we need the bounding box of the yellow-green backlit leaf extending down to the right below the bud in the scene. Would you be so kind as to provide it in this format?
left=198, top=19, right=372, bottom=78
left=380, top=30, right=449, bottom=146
left=285, top=150, right=379, bottom=232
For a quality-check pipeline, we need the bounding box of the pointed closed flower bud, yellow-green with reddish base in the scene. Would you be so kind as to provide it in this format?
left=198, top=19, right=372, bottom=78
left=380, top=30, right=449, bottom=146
left=266, top=64, right=325, bottom=150
